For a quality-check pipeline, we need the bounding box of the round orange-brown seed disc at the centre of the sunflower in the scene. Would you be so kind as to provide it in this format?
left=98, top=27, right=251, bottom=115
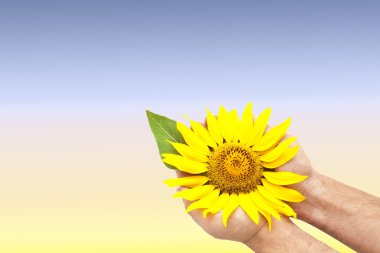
left=208, top=143, right=263, bottom=194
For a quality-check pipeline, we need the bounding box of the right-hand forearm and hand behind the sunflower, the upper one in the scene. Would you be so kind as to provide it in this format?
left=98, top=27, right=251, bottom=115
left=279, top=142, right=380, bottom=252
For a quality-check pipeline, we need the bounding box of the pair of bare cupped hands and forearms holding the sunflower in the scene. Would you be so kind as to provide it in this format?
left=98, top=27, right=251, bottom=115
left=178, top=136, right=380, bottom=252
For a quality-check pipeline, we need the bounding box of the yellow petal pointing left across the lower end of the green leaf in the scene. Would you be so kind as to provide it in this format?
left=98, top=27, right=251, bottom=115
left=162, top=154, right=208, bottom=174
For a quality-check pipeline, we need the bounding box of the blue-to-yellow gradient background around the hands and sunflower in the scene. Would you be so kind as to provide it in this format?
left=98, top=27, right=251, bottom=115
left=0, top=1, right=380, bottom=252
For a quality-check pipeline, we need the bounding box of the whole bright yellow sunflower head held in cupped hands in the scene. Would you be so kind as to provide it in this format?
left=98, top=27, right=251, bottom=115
left=162, top=103, right=307, bottom=230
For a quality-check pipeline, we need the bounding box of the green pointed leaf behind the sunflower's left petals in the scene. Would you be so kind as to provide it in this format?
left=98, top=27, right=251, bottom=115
left=146, top=110, right=185, bottom=169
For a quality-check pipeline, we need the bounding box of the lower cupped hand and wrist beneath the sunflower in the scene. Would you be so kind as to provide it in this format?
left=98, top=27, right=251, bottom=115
left=177, top=140, right=334, bottom=253
